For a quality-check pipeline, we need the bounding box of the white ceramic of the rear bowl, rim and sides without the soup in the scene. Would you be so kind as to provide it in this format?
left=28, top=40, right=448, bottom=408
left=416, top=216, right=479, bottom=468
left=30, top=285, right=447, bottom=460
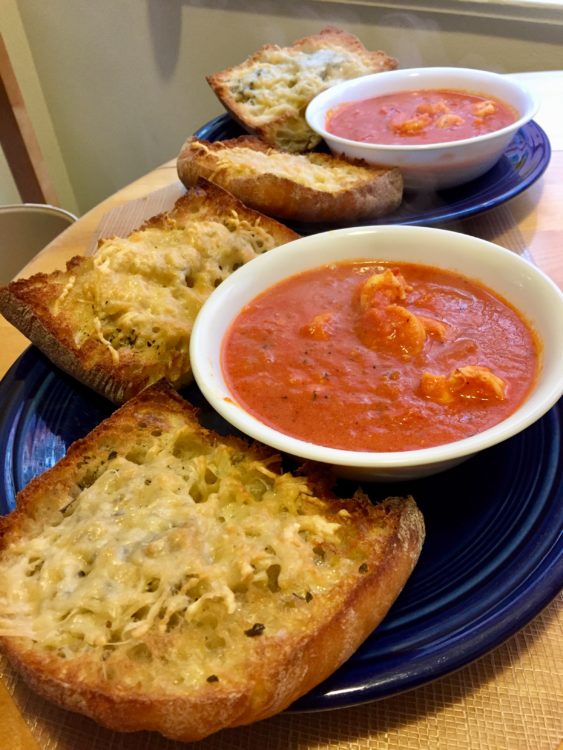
left=306, top=68, right=538, bottom=190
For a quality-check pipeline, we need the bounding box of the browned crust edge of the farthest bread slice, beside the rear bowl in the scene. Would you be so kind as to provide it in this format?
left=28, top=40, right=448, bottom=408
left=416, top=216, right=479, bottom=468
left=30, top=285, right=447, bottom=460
left=206, top=26, right=398, bottom=151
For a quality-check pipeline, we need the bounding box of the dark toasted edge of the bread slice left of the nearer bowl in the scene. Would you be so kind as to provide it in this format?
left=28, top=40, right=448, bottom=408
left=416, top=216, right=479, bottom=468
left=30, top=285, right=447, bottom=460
left=0, top=180, right=299, bottom=404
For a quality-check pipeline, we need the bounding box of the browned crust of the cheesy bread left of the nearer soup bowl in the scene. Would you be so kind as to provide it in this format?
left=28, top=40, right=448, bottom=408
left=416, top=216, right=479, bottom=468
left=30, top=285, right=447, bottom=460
left=0, top=181, right=298, bottom=404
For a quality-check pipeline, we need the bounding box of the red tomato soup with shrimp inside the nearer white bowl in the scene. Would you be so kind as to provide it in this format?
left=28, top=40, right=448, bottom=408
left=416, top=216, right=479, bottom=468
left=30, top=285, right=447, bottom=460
left=222, top=261, right=540, bottom=451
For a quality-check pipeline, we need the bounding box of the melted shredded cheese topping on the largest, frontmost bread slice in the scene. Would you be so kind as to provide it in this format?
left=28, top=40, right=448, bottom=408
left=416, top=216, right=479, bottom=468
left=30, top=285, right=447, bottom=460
left=0, top=424, right=368, bottom=691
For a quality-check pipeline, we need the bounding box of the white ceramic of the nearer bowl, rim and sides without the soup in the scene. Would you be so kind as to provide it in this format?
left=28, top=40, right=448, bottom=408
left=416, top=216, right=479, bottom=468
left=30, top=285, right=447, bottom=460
left=190, top=226, right=563, bottom=481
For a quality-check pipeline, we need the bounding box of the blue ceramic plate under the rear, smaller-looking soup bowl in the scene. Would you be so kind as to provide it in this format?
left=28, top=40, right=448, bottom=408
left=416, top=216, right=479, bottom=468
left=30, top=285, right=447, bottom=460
left=195, top=115, right=551, bottom=234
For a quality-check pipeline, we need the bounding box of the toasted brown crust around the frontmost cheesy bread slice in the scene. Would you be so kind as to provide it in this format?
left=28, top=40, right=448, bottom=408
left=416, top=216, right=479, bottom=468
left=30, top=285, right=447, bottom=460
left=0, top=384, right=424, bottom=741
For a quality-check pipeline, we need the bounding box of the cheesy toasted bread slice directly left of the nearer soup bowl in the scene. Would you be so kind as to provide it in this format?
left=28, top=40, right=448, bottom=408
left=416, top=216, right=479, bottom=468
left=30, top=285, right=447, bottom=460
left=0, top=183, right=298, bottom=403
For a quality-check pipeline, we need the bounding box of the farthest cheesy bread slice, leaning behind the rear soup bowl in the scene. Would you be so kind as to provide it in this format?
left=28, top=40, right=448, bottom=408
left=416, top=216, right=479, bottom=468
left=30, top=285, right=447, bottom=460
left=207, top=26, right=397, bottom=152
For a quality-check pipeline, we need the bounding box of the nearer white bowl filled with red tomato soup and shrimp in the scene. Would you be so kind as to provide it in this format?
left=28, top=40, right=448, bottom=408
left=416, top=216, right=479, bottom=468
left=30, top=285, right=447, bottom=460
left=190, top=225, right=563, bottom=481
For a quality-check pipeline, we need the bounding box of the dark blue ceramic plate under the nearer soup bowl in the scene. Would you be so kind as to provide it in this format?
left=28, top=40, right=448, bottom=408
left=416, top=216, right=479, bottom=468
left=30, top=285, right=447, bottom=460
left=0, top=347, right=563, bottom=711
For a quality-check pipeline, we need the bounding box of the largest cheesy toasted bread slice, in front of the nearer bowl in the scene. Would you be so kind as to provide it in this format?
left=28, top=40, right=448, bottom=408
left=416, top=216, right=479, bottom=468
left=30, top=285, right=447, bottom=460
left=0, top=384, right=424, bottom=741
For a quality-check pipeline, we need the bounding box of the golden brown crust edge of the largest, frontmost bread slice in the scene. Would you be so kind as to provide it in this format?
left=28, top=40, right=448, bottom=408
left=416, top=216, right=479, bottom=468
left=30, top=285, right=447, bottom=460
left=0, top=383, right=424, bottom=742
